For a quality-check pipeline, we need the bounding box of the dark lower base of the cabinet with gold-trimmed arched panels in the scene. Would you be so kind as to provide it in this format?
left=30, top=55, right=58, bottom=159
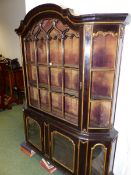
left=24, top=112, right=117, bottom=175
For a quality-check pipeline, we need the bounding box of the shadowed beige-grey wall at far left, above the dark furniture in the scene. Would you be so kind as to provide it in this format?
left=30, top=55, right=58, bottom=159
left=0, top=0, right=25, bottom=63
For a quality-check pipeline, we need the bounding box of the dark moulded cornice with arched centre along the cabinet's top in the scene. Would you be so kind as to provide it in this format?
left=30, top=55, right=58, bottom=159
left=15, top=4, right=130, bottom=35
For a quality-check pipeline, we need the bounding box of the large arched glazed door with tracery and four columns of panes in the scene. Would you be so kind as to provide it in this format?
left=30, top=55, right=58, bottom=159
left=24, top=18, right=81, bottom=126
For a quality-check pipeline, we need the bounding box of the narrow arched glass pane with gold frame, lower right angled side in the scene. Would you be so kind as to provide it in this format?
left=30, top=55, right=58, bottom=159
left=91, top=146, right=105, bottom=175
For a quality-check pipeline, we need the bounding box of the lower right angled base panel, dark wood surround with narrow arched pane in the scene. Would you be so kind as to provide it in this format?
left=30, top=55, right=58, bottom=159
left=87, top=140, right=111, bottom=175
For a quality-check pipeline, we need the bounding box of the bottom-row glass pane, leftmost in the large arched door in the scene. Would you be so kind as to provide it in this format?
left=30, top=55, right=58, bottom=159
left=29, top=87, right=38, bottom=107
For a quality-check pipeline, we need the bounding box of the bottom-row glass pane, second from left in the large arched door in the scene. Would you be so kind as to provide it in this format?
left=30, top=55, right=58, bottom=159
left=40, top=89, right=49, bottom=110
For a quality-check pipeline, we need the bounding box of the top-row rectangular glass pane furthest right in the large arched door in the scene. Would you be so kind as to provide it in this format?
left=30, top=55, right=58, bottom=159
left=64, top=37, right=79, bottom=66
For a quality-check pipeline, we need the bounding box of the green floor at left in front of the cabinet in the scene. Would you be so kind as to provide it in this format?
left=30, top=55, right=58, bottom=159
left=0, top=105, right=63, bottom=175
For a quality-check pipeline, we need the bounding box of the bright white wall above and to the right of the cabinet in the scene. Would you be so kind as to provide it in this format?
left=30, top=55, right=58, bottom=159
left=25, top=0, right=131, bottom=175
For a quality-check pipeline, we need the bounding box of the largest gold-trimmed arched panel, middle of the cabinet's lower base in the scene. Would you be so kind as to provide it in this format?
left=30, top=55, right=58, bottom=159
left=50, top=127, right=78, bottom=174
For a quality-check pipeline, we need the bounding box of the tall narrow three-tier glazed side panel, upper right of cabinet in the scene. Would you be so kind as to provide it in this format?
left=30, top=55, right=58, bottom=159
left=88, top=24, right=119, bottom=130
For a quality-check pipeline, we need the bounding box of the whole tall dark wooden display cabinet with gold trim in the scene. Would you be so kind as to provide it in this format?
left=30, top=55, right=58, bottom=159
left=16, top=4, right=129, bottom=175
